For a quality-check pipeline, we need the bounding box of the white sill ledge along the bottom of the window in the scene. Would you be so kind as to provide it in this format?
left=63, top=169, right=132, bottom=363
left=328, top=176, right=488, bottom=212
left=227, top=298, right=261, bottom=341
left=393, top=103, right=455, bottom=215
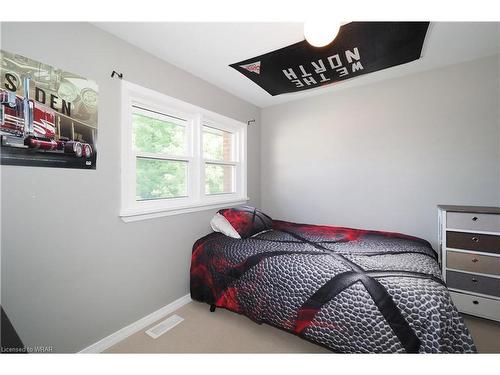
left=120, top=197, right=250, bottom=223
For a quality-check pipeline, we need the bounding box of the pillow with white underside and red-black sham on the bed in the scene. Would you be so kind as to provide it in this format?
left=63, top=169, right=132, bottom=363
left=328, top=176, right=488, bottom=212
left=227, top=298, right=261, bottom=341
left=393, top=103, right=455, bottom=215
left=210, top=206, right=273, bottom=239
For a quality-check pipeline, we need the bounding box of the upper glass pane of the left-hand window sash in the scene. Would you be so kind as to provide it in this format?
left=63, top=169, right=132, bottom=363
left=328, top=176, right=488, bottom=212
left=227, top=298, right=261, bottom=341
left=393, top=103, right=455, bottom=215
left=132, top=111, right=187, bottom=155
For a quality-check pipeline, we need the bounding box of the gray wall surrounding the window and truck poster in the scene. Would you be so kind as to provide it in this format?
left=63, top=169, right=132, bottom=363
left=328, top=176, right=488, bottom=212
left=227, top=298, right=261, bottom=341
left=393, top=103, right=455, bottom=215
left=1, top=23, right=260, bottom=352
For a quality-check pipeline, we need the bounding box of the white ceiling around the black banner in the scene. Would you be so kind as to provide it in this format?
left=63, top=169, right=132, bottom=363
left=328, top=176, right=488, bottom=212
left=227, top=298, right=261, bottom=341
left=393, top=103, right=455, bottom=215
left=94, top=22, right=500, bottom=107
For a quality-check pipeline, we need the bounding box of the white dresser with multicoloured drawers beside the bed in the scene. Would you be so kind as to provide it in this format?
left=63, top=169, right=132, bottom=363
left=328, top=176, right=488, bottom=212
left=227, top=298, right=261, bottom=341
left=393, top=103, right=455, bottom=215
left=438, top=205, right=500, bottom=321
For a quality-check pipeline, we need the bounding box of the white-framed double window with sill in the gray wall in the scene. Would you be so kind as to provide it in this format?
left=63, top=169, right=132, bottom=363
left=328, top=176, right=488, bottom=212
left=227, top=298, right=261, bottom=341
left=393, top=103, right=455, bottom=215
left=120, top=82, right=248, bottom=221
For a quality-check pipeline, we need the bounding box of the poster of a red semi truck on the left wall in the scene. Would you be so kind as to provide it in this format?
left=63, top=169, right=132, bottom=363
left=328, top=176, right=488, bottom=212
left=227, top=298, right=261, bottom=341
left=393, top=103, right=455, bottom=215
left=0, top=50, right=98, bottom=169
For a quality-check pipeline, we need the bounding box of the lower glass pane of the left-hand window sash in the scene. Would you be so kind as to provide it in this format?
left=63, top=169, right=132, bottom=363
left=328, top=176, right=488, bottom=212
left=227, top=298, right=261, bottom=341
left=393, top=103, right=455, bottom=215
left=136, top=158, right=188, bottom=201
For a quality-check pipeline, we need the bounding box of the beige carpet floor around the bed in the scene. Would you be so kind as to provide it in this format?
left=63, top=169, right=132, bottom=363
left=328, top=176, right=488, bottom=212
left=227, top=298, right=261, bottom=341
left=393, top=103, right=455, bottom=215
left=105, top=302, right=500, bottom=353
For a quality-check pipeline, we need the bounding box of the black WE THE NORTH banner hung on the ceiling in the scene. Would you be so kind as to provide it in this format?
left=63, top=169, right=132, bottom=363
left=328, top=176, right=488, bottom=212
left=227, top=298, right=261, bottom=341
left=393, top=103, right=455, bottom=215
left=230, top=22, right=429, bottom=96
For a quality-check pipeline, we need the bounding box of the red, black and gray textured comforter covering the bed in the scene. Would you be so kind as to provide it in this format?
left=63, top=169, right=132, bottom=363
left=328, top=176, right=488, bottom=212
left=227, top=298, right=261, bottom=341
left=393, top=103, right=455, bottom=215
left=191, top=209, right=476, bottom=353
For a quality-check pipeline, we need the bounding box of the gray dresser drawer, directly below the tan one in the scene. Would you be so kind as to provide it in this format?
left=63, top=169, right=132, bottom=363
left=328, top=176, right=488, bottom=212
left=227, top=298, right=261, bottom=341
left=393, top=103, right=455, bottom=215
left=446, top=271, right=500, bottom=297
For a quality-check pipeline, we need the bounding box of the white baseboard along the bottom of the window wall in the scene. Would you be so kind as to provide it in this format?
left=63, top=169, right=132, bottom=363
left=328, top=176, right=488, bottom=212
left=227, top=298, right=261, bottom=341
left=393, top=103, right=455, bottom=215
left=78, top=294, right=191, bottom=353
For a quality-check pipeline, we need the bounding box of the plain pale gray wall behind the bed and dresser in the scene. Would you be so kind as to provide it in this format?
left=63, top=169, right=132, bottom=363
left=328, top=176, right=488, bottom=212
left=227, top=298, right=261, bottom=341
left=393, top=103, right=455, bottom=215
left=261, top=56, right=500, bottom=251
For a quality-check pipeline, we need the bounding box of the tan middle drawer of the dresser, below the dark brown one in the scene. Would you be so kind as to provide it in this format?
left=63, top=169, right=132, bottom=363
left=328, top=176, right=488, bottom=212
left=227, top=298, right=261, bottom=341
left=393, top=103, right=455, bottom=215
left=446, top=250, right=500, bottom=276
